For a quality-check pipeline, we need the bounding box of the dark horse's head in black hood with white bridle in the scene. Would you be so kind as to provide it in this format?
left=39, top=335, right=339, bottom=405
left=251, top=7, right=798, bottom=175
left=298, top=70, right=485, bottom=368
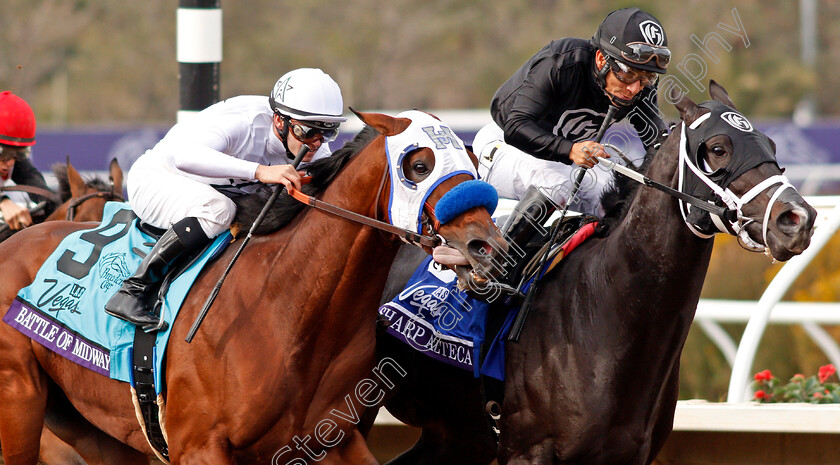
left=671, top=81, right=817, bottom=261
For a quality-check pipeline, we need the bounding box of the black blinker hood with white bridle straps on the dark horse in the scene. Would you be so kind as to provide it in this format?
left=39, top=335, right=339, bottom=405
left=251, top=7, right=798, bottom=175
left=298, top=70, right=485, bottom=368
left=679, top=101, right=793, bottom=252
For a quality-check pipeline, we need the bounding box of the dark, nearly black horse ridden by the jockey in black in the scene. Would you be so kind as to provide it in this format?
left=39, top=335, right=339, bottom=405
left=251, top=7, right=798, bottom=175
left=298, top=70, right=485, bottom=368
left=369, top=81, right=816, bottom=465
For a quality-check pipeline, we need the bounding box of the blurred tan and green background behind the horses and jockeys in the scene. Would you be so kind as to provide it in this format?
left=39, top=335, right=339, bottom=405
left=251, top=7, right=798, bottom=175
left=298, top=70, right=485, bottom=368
left=0, top=0, right=840, bottom=401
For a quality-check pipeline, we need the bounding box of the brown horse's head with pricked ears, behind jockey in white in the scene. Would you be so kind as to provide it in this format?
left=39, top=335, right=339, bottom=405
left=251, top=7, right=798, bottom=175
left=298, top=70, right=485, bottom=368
left=45, top=158, right=123, bottom=222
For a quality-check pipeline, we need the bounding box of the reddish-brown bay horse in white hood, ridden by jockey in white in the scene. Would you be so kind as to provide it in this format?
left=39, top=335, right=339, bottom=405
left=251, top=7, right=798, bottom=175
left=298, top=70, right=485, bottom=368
left=0, top=113, right=505, bottom=465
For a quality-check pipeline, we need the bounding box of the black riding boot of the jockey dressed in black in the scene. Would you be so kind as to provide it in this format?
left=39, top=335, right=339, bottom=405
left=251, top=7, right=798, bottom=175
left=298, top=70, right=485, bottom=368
left=502, top=186, right=557, bottom=250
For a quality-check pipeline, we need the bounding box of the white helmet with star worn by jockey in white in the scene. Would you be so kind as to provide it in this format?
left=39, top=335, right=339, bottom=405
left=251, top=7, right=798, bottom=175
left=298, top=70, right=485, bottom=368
left=268, top=68, right=347, bottom=129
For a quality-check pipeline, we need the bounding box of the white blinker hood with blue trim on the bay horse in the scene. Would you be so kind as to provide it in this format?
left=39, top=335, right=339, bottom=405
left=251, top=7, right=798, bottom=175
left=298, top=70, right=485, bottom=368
left=386, top=110, right=478, bottom=233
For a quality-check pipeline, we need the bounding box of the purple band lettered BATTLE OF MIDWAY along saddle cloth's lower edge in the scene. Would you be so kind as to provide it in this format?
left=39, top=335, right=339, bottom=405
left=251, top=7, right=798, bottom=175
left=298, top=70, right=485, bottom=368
left=3, top=298, right=111, bottom=376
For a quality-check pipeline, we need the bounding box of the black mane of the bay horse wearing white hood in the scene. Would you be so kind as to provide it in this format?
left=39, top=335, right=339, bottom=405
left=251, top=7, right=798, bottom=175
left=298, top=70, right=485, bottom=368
left=232, top=126, right=380, bottom=234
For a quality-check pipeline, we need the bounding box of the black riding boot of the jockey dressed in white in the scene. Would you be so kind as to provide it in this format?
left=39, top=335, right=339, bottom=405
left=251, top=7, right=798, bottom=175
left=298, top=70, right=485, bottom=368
left=105, top=217, right=210, bottom=326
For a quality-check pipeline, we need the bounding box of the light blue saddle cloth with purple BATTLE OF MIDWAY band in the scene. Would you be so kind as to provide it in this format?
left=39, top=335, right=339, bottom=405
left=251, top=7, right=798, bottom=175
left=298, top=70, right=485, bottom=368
left=3, top=202, right=231, bottom=386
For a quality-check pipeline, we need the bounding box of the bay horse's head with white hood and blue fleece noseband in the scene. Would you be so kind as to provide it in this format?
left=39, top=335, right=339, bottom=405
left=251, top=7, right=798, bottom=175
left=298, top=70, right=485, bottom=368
left=356, top=111, right=508, bottom=289
